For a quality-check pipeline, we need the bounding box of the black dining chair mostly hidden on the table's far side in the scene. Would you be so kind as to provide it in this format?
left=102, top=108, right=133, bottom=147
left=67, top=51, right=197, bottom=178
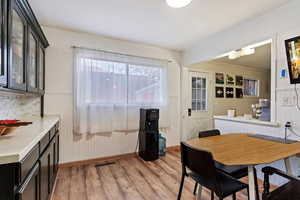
left=194, top=129, right=259, bottom=200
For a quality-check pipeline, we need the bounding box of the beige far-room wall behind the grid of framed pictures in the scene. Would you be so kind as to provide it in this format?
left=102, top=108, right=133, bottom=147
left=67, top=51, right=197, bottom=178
left=189, top=61, right=271, bottom=115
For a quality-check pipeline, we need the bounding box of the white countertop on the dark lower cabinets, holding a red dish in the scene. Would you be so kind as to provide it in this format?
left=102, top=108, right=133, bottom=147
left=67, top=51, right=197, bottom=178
left=0, top=115, right=60, bottom=164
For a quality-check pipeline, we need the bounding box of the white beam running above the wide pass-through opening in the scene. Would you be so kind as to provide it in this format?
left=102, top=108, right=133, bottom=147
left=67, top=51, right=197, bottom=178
left=183, top=0, right=300, bottom=66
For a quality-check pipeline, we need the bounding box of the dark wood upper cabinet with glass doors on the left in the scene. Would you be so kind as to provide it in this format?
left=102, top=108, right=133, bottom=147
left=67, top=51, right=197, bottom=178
left=0, top=0, right=49, bottom=95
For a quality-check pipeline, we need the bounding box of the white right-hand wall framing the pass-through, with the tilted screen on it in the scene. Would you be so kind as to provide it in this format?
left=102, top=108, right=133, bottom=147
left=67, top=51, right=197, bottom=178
left=184, top=0, right=300, bottom=185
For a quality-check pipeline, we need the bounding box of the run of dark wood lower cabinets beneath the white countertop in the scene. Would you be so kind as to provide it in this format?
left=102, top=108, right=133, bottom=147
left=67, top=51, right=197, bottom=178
left=0, top=122, right=59, bottom=200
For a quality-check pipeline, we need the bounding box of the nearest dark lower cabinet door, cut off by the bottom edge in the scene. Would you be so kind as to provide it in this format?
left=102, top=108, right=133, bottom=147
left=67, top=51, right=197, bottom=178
left=17, top=163, right=40, bottom=200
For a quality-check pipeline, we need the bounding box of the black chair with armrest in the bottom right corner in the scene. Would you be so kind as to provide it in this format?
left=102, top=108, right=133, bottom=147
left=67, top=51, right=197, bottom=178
left=262, top=167, right=300, bottom=200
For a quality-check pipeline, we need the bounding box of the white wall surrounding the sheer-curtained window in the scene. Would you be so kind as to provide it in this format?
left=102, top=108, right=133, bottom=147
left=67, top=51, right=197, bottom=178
left=43, top=27, right=181, bottom=163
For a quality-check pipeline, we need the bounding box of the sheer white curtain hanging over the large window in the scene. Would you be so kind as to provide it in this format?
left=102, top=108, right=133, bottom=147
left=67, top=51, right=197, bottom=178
left=74, top=48, right=169, bottom=134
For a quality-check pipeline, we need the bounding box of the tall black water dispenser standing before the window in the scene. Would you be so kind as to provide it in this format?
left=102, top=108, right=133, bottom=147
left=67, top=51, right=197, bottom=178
left=139, top=109, right=159, bottom=161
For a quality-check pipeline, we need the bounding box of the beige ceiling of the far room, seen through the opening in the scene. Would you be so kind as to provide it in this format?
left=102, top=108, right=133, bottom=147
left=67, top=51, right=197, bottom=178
left=214, top=44, right=271, bottom=69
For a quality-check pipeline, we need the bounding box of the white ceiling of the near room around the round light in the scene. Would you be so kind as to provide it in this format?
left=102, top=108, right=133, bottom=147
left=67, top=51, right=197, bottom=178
left=28, top=0, right=290, bottom=50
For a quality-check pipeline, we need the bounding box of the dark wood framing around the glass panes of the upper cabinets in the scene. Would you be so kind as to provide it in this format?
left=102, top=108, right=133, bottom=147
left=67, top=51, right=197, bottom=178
left=0, top=0, right=49, bottom=97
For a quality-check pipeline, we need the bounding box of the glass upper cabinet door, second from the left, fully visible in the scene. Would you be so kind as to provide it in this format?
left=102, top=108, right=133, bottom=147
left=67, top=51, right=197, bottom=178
left=9, top=4, right=27, bottom=90
